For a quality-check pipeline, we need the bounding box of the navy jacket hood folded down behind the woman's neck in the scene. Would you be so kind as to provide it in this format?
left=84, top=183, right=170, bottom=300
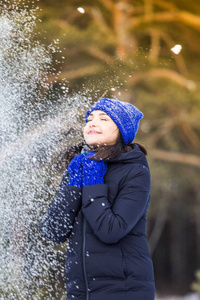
left=105, top=144, right=149, bottom=168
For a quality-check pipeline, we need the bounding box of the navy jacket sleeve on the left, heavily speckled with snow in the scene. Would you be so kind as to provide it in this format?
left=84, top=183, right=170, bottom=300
left=40, top=171, right=81, bottom=244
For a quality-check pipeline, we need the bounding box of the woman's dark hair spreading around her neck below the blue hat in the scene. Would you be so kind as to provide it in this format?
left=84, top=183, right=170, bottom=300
left=64, top=133, right=147, bottom=166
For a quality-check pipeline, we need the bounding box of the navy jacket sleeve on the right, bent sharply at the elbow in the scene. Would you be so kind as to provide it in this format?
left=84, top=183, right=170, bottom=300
left=82, top=164, right=150, bottom=244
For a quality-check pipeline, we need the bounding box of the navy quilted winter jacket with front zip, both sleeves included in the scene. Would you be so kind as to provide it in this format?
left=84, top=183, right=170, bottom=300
left=41, top=145, right=155, bottom=300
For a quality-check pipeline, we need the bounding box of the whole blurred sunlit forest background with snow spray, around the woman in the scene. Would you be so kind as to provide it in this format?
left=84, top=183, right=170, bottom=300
left=0, top=0, right=200, bottom=300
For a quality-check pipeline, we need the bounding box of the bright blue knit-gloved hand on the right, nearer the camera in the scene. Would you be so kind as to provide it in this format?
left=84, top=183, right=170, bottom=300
left=82, top=152, right=107, bottom=186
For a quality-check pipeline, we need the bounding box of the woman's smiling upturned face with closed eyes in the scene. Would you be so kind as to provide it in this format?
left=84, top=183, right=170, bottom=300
left=83, top=110, right=119, bottom=146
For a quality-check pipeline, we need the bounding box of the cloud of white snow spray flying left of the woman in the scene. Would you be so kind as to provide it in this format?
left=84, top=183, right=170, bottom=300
left=0, top=5, right=90, bottom=300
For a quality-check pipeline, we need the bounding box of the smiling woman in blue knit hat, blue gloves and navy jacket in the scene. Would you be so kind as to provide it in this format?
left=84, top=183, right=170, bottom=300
left=41, top=98, right=155, bottom=300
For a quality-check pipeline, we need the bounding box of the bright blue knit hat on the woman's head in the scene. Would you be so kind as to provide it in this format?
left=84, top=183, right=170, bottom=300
left=85, top=98, right=143, bottom=145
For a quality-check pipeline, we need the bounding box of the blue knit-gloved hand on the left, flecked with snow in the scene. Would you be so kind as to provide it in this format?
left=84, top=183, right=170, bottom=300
left=67, top=154, right=83, bottom=187
